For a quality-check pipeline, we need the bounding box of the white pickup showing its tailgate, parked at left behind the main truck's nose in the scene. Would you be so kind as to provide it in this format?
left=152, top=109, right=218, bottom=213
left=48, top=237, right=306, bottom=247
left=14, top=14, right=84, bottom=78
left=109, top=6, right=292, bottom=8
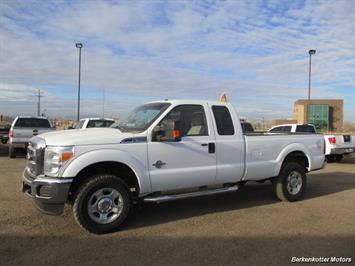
left=9, top=116, right=55, bottom=158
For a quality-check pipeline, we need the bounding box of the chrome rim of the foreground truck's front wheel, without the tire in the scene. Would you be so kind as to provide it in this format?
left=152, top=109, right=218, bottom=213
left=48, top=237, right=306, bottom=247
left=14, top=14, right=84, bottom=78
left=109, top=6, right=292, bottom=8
left=87, top=188, right=123, bottom=224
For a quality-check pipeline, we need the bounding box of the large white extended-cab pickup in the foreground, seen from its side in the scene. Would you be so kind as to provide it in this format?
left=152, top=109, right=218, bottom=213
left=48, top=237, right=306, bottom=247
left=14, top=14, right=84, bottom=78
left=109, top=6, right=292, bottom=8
left=22, top=100, right=325, bottom=233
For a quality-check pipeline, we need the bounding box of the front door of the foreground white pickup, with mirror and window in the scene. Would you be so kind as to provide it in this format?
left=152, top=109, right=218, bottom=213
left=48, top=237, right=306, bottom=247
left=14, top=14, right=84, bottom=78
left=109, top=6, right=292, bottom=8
left=148, top=105, right=216, bottom=191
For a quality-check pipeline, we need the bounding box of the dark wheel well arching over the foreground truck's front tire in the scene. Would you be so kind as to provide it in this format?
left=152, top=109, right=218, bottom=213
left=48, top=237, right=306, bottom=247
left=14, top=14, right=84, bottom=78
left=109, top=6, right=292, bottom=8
left=68, top=161, right=139, bottom=202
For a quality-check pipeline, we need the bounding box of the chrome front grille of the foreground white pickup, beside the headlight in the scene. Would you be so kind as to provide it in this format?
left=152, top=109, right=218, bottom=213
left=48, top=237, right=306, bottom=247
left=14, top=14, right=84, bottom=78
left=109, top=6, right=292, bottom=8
left=27, top=137, right=46, bottom=176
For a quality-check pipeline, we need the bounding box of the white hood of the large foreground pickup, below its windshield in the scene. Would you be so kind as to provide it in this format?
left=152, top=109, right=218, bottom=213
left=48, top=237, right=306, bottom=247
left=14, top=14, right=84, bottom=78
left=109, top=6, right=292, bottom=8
left=38, top=128, right=133, bottom=146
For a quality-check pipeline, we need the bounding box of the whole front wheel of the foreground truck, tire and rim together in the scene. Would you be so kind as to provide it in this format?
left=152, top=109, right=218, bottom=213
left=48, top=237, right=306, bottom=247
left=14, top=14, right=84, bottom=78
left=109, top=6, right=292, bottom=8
left=73, top=175, right=131, bottom=234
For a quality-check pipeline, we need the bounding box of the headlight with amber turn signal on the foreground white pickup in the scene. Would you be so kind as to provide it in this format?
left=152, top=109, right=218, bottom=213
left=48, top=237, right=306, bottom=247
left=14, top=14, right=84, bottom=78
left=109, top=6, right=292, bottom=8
left=44, top=146, right=74, bottom=177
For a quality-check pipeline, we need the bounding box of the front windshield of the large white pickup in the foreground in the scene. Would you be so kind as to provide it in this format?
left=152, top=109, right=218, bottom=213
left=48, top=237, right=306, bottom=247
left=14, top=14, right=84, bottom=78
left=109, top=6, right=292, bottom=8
left=111, top=103, right=170, bottom=132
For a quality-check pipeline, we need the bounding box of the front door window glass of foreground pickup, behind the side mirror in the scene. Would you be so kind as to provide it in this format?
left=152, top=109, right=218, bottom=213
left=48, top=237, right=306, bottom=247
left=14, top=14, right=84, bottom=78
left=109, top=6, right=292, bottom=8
left=159, top=105, right=208, bottom=139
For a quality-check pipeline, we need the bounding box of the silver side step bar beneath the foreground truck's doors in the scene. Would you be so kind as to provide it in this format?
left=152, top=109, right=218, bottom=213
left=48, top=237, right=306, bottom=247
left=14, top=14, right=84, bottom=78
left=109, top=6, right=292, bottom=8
left=144, top=185, right=239, bottom=203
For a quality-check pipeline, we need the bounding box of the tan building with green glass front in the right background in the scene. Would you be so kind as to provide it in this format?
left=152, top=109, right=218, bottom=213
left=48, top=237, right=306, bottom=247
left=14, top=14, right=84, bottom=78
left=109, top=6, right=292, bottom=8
left=294, top=99, right=344, bottom=131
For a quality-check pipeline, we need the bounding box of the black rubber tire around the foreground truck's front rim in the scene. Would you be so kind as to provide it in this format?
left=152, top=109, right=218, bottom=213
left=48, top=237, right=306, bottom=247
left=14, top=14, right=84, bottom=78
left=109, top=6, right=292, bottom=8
left=73, top=174, right=132, bottom=234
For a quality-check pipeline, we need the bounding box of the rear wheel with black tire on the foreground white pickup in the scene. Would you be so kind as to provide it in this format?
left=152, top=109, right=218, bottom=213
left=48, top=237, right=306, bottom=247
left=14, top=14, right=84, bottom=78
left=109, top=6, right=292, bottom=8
left=273, top=162, right=307, bottom=202
